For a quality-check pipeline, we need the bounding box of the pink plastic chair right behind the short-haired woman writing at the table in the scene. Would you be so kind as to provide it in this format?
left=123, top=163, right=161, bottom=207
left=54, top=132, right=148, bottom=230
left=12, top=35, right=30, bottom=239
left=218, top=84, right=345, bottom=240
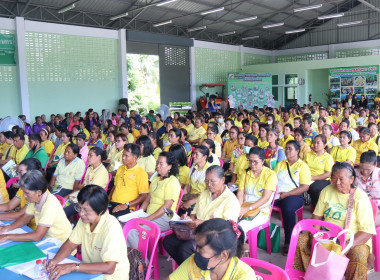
left=123, top=219, right=161, bottom=280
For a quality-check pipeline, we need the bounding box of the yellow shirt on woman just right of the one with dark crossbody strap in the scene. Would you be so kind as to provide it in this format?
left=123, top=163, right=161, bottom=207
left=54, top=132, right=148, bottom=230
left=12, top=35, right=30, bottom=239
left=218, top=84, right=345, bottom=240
left=303, top=151, right=334, bottom=180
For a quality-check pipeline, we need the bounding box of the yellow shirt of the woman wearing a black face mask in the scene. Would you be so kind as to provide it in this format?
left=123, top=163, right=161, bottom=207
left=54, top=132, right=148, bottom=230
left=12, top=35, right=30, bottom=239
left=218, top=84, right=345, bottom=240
left=169, top=254, right=256, bottom=280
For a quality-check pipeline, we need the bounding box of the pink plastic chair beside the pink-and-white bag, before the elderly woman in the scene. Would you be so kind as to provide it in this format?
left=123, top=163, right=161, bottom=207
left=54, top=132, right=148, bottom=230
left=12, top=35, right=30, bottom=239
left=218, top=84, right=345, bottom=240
left=285, top=219, right=346, bottom=280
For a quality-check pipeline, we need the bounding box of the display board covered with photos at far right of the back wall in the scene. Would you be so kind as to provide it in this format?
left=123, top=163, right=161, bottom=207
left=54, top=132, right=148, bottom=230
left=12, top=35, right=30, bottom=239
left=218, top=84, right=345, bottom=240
left=329, top=65, right=379, bottom=106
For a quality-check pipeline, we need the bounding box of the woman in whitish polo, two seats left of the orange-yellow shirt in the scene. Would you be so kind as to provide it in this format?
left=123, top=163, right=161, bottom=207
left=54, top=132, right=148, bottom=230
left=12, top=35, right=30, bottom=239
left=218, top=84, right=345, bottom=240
left=50, top=144, right=85, bottom=199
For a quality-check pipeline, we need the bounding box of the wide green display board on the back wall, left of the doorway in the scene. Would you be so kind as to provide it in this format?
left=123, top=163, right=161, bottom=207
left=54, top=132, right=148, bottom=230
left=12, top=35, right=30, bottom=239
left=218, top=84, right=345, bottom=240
left=228, top=73, right=275, bottom=110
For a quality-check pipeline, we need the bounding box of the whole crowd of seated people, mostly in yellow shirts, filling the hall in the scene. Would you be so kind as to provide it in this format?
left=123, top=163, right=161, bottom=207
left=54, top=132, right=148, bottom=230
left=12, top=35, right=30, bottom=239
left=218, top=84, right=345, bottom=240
left=0, top=100, right=380, bottom=280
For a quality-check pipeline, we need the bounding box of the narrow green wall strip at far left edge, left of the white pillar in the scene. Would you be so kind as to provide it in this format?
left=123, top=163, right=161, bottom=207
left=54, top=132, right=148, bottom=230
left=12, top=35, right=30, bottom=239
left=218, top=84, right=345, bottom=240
left=0, top=30, right=21, bottom=118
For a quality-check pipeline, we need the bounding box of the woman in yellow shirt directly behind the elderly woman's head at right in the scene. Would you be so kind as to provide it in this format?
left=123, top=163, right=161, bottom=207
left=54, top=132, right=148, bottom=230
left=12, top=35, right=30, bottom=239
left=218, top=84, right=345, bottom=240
left=330, top=130, right=356, bottom=166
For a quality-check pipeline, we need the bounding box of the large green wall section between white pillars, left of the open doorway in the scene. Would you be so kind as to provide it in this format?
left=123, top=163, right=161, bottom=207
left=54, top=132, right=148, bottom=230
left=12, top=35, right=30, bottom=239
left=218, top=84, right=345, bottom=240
left=25, top=32, right=119, bottom=120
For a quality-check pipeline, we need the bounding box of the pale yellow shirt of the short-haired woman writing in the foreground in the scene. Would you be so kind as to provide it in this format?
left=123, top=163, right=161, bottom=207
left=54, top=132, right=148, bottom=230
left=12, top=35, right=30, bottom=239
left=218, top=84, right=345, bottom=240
left=69, top=212, right=130, bottom=280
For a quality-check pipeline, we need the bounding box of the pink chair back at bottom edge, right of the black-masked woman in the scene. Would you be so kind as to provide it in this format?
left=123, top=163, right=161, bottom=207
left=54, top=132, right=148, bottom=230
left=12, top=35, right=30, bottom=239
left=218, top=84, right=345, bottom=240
left=240, top=258, right=290, bottom=280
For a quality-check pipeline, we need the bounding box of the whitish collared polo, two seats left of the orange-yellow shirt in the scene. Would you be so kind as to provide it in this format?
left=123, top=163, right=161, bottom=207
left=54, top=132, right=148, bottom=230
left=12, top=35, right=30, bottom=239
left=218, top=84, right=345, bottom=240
left=54, top=157, right=86, bottom=190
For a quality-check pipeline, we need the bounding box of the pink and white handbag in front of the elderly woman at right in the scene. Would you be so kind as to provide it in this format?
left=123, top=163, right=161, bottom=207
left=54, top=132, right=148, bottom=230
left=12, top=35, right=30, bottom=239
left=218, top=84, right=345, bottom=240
left=304, top=229, right=354, bottom=280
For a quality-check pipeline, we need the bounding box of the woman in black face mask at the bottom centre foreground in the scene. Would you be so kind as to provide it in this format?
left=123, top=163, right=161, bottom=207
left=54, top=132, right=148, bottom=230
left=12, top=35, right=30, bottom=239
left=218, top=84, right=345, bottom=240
left=167, top=219, right=256, bottom=280
